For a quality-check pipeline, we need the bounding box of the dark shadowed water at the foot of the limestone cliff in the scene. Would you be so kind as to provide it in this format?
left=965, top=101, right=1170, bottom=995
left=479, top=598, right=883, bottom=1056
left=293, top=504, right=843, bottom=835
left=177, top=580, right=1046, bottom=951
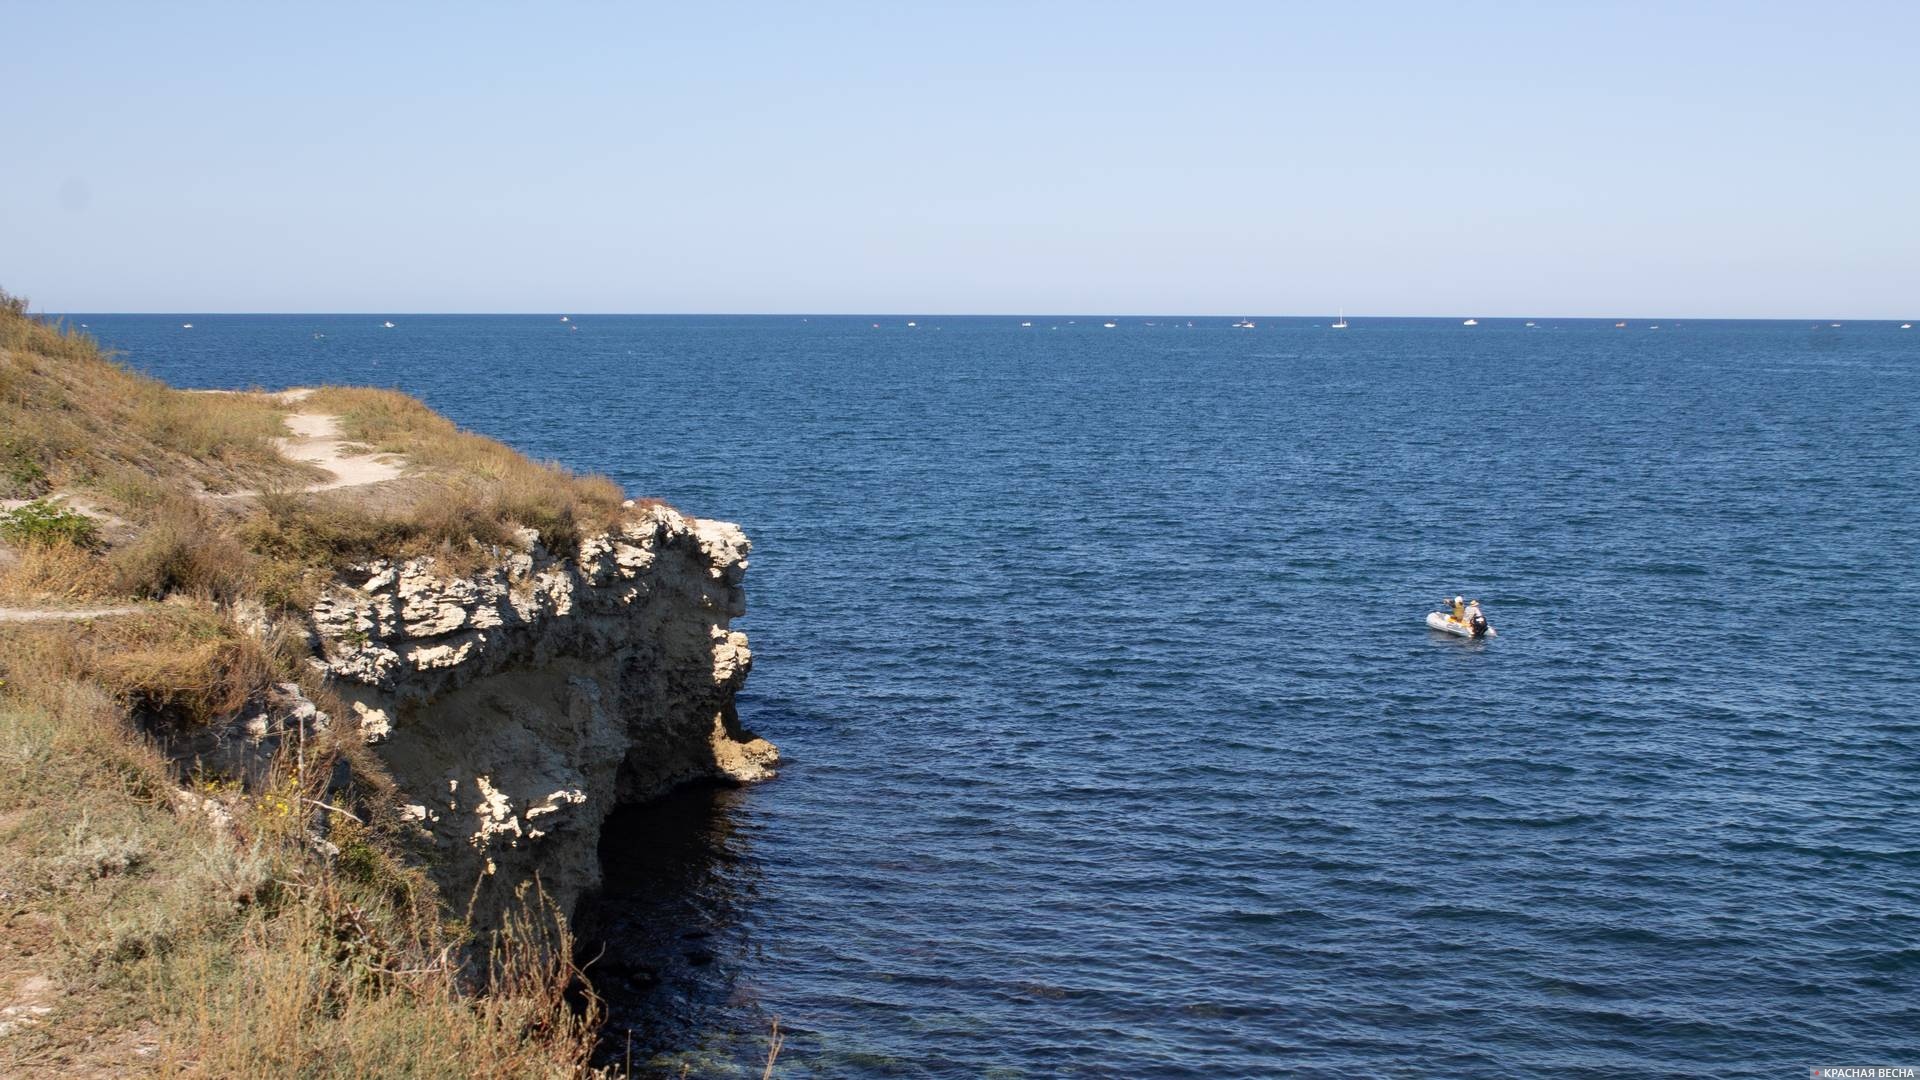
left=574, top=772, right=758, bottom=1076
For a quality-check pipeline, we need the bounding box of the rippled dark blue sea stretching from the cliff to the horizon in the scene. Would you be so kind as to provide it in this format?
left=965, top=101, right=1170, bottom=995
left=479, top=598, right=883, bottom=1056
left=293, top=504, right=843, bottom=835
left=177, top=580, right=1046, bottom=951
left=73, top=313, right=1920, bottom=1078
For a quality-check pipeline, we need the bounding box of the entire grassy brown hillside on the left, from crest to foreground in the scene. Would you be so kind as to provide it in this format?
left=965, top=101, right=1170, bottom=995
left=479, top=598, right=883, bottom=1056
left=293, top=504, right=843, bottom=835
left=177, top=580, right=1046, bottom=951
left=0, top=294, right=620, bottom=1076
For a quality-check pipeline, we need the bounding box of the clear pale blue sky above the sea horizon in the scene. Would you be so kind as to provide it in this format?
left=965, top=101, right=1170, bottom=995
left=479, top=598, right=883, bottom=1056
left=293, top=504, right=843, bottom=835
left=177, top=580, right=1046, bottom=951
left=0, top=0, right=1920, bottom=319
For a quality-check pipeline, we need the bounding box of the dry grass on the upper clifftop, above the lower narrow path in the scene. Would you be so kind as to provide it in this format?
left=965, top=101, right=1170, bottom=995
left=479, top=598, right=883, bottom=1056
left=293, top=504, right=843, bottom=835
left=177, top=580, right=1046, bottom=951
left=0, top=292, right=645, bottom=607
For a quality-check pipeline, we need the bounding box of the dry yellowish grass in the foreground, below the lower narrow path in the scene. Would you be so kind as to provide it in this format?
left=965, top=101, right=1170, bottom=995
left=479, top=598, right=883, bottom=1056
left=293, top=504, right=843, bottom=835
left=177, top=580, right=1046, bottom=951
left=0, top=611, right=597, bottom=1078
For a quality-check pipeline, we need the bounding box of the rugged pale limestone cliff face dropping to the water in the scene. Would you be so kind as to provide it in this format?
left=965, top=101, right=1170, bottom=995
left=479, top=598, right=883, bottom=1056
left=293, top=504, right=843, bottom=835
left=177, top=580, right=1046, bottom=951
left=311, top=507, right=780, bottom=922
